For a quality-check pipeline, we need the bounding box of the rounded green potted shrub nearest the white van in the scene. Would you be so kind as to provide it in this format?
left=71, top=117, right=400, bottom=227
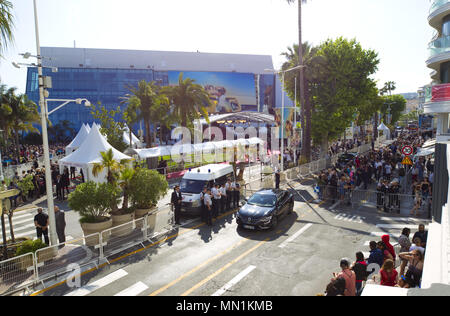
left=129, top=168, right=169, bottom=227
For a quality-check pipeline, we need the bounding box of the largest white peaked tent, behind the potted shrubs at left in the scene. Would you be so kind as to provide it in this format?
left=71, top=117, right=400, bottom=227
left=58, top=125, right=131, bottom=182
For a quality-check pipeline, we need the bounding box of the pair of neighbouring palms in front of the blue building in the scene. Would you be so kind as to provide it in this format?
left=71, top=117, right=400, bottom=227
left=122, top=73, right=211, bottom=147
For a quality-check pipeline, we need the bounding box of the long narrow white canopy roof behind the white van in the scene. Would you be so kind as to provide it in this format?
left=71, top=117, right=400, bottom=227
left=128, top=137, right=264, bottom=159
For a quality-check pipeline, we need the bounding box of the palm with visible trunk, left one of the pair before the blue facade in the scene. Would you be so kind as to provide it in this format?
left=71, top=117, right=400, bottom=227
left=122, top=80, right=168, bottom=147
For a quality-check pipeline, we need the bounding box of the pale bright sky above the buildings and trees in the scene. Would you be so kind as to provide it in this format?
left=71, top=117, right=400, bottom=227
left=0, top=0, right=433, bottom=93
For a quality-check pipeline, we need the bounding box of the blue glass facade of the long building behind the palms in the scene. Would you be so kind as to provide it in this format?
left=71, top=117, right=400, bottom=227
left=26, top=67, right=275, bottom=130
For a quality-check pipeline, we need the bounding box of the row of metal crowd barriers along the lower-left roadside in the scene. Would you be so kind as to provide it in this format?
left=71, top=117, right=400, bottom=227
left=0, top=207, right=173, bottom=295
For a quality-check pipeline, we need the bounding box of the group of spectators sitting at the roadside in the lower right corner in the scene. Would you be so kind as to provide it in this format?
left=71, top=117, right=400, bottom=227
left=325, top=224, right=428, bottom=296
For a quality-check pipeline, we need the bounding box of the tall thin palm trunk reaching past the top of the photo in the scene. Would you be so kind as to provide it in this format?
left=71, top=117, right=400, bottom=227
left=286, top=0, right=311, bottom=161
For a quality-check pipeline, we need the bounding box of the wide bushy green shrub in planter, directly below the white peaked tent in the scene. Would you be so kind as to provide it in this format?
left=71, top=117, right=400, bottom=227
left=69, top=181, right=120, bottom=223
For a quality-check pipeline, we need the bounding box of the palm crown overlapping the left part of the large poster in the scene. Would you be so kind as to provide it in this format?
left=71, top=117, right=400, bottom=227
left=163, top=73, right=211, bottom=127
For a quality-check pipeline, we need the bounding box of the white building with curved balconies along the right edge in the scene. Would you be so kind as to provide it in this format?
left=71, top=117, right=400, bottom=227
left=422, top=0, right=450, bottom=295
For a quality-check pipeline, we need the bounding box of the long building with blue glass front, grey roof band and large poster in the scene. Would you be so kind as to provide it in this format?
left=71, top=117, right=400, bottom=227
left=26, top=47, right=277, bottom=129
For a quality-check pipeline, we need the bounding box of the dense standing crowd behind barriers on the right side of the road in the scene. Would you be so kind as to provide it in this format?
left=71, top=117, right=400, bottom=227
left=316, top=134, right=434, bottom=216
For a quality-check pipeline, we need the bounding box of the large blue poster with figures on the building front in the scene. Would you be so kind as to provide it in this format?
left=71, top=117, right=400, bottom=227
left=169, top=71, right=258, bottom=113
